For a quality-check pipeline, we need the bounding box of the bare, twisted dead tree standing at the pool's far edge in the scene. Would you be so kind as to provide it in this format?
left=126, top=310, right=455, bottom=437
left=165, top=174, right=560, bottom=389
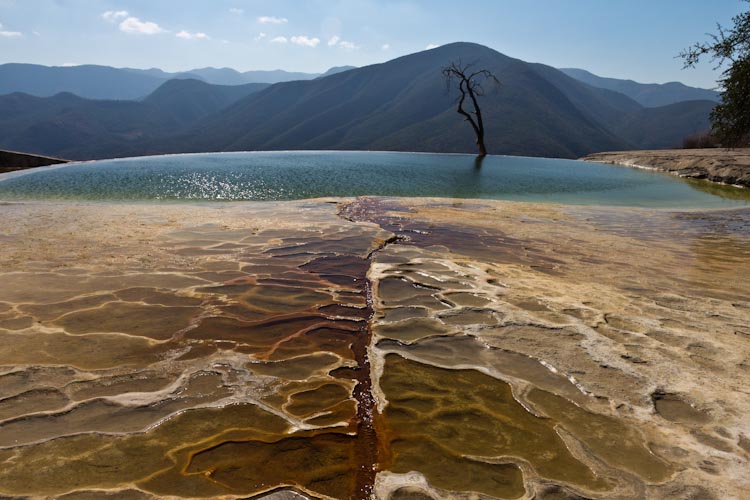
left=443, top=60, right=500, bottom=156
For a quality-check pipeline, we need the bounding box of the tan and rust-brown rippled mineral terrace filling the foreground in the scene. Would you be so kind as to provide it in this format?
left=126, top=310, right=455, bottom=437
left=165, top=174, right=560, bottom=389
left=0, top=198, right=750, bottom=499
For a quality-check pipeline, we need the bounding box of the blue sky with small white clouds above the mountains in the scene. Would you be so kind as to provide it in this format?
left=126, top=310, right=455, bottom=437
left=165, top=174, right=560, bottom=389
left=0, top=0, right=748, bottom=87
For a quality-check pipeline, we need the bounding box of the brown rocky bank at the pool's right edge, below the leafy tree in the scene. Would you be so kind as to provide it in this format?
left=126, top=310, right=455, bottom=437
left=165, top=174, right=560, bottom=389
left=581, top=148, right=750, bottom=187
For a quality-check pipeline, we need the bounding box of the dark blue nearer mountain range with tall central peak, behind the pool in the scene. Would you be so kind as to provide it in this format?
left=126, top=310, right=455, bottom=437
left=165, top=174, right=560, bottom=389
left=0, top=42, right=716, bottom=159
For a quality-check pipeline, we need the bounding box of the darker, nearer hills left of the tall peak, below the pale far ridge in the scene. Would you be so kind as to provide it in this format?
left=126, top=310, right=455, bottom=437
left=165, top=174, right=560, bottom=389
left=0, top=80, right=268, bottom=159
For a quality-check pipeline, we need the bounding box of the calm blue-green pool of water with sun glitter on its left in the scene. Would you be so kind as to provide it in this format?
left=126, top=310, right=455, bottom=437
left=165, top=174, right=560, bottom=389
left=0, top=151, right=750, bottom=208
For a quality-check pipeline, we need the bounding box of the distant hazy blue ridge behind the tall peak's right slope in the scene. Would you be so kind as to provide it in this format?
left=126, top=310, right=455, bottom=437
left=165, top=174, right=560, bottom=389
left=560, top=68, right=719, bottom=107
